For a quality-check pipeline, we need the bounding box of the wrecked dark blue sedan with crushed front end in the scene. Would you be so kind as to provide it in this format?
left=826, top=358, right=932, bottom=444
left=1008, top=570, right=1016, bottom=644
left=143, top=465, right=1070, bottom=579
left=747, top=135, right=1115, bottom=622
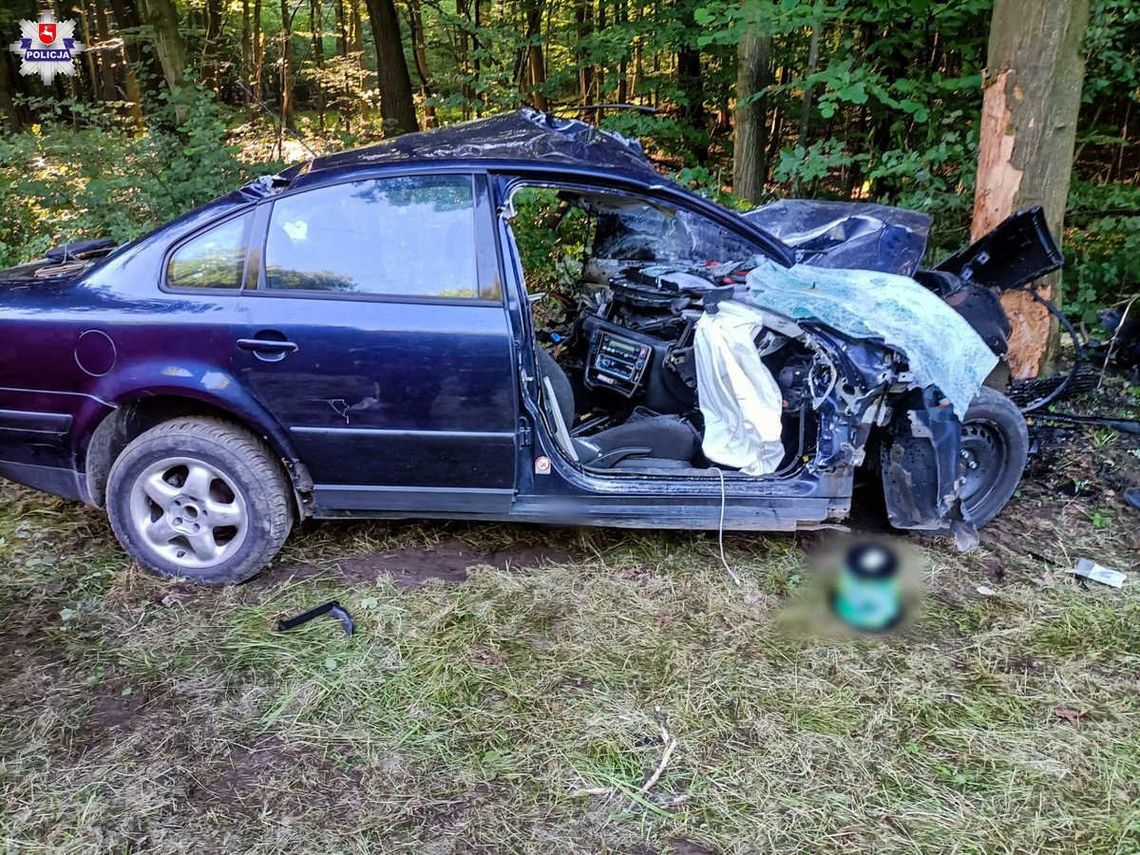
left=0, top=111, right=1060, bottom=584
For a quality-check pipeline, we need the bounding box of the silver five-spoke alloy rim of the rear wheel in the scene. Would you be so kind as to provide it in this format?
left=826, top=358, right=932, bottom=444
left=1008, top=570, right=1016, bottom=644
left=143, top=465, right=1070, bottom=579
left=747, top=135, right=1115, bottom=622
left=130, top=457, right=250, bottom=570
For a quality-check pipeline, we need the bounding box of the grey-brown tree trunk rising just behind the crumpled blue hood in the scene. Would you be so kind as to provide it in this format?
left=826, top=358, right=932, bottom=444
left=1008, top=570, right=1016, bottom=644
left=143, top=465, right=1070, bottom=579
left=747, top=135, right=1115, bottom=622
left=732, top=32, right=772, bottom=204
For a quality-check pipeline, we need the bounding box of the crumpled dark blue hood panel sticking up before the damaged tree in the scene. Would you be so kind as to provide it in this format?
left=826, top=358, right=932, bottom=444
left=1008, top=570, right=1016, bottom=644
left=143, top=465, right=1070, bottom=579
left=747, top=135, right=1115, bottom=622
left=741, top=198, right=930, bottom=276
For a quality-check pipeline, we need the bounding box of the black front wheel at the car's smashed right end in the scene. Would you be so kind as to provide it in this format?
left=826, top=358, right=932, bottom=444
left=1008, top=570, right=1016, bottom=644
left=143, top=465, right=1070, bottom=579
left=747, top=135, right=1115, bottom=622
left=959, top=386, right=1029, bottom=528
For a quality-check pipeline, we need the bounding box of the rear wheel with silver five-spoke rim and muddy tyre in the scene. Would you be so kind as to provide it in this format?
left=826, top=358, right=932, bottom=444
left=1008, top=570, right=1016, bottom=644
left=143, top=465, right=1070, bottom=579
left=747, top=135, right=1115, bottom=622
left=107, top=418, right=293, bottom=585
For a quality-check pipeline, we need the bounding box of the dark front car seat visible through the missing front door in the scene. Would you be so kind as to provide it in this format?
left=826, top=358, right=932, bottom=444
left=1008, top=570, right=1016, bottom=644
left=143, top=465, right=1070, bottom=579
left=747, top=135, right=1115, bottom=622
left=535, top=349, right=700, bottom=470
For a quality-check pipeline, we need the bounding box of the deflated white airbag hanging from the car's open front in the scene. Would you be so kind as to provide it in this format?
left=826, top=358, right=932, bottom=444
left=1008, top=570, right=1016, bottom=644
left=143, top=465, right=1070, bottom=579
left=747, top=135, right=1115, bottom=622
left=694, top=302, right=784, bottom=475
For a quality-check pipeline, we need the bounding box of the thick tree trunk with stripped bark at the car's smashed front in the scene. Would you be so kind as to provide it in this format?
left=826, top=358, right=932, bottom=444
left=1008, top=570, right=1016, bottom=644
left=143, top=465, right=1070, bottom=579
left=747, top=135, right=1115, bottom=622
left=971, top=0, right=1089, bottom=377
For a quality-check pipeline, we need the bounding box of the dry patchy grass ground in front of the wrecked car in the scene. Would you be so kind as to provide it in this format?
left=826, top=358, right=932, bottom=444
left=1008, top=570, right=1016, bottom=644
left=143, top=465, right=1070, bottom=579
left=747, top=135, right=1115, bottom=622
left=0, top=419, right=1140, bottom=855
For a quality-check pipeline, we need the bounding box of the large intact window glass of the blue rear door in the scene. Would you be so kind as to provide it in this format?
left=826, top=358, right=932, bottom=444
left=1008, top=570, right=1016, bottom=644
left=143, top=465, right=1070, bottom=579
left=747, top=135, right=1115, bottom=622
left=264, top=176, right=479, bottom=299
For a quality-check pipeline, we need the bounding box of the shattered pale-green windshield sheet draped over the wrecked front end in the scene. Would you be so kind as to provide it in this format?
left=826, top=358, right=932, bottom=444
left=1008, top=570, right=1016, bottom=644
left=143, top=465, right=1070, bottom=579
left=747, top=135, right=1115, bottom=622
left=736, top=257, right=998, bottom=418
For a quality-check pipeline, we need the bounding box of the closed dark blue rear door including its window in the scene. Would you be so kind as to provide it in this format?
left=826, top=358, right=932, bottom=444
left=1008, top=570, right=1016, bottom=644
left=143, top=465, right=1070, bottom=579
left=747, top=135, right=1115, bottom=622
left=235, top=173, right=516, bottom=514
